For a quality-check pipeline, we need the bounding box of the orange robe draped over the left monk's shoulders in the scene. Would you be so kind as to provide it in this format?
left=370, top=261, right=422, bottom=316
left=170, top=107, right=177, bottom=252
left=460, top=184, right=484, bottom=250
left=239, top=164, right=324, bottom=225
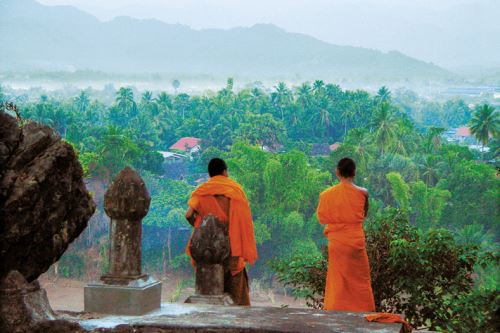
left=186, top=176, right=257, bottom=275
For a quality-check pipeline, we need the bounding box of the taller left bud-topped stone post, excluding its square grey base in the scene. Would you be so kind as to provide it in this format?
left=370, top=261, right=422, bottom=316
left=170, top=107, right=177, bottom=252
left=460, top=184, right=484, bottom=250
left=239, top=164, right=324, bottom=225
left=101, top=167, right=151, bottom=284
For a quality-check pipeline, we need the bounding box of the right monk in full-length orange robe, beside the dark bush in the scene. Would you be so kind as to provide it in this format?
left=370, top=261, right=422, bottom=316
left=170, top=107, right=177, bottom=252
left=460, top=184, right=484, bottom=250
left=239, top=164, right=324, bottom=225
left=317, top=158, right=375, bottom=312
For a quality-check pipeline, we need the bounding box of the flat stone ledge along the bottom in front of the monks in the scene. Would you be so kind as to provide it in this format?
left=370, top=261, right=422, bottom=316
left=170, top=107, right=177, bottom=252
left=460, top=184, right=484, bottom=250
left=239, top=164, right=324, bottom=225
left=73, top=303, right=401, bottom=333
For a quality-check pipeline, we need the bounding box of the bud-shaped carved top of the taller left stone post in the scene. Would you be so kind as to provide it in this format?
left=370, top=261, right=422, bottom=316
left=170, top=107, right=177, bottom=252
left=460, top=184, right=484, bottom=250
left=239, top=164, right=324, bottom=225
left=104, top=167, right=151, bottom=220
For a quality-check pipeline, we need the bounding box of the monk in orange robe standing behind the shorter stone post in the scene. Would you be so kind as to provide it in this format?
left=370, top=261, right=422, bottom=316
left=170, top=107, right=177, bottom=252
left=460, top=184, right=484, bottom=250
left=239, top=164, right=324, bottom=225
left=186, top=158, right=257, bottom=305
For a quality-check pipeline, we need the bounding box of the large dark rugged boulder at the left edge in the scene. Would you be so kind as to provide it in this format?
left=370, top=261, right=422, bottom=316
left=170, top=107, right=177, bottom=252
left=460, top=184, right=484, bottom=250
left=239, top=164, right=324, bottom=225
left=0, top=111, right=95, bottom=282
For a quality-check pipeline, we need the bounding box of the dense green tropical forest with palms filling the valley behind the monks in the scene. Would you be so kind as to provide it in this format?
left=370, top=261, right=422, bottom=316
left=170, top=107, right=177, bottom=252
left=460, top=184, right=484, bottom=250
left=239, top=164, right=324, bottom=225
left=0, top=79, right=500, bottom=332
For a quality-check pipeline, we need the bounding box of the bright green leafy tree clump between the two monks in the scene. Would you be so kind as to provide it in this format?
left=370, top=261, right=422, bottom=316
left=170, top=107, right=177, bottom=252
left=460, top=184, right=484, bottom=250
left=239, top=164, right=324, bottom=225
left=228, top=143, right=331, bottom=265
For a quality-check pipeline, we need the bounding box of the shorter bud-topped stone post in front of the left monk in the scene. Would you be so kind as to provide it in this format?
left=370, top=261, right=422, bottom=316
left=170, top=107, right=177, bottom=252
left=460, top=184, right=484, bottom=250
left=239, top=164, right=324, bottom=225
left=186, top=215, right=233, bottom=305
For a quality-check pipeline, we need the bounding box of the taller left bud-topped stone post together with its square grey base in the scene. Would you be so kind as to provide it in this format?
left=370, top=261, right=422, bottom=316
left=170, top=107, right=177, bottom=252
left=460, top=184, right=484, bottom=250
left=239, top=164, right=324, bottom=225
left=84, top=167, right=161, bottom=315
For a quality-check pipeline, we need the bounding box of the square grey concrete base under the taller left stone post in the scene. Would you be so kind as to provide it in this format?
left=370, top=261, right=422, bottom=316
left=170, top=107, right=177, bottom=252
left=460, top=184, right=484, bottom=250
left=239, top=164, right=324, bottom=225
left=84, top=279, right=161, bottom=316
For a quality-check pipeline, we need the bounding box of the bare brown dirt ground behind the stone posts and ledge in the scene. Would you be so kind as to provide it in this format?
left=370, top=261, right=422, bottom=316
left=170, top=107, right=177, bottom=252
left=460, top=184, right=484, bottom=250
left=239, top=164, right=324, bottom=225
left=39, top=274, right=306, bottom=312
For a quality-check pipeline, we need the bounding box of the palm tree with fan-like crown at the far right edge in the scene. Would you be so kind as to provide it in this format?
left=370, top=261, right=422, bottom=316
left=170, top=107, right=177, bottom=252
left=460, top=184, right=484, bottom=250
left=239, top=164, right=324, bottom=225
left=470, top=104, right=500, bottom=154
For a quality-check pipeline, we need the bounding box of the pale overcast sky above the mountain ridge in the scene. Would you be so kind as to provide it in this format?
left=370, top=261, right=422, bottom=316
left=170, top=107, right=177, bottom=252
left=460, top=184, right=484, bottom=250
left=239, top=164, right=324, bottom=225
left=38, top=0, right=500, bottom=68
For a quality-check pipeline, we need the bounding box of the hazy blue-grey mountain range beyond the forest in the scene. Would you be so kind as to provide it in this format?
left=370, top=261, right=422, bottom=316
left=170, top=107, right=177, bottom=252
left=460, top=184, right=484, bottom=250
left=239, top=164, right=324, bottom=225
left=0, top=0, right=449, bottom=79
